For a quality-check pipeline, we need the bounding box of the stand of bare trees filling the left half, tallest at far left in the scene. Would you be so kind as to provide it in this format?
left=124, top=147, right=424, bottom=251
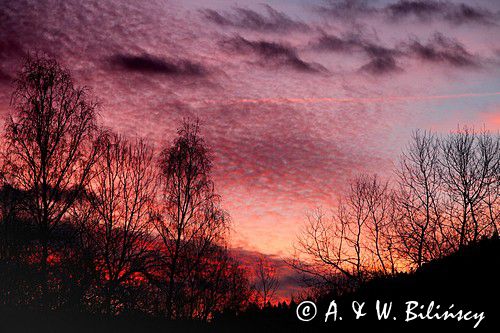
left=0, top=55, right=254, bottom=321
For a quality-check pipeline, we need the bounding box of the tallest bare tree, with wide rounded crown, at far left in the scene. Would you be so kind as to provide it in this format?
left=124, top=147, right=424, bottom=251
left=3, top=56, right=102, bottom=295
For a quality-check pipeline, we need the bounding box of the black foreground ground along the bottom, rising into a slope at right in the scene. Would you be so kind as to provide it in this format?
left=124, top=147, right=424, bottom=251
left=0, top=239, right=500, bottom=333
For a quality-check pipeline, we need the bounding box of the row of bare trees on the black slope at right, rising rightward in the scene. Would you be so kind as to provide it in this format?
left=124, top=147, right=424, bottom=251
left=289, top=128, right=500, bottom=290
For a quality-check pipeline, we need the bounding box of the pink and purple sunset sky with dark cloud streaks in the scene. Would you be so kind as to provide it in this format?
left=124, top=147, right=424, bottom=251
left=0, top=0, right=500, bottom=294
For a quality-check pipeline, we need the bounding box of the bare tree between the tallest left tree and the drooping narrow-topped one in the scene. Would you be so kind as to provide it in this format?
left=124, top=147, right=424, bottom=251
left=87, top=134, right=156, bottom=314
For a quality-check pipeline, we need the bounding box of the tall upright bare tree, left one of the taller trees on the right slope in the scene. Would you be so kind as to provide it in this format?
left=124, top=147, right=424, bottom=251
left=397, top=131, right=447, bottom=267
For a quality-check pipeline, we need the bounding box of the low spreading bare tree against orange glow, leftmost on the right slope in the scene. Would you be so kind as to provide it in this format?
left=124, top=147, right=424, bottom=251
left=288, top=175, right=378, bottom=288
